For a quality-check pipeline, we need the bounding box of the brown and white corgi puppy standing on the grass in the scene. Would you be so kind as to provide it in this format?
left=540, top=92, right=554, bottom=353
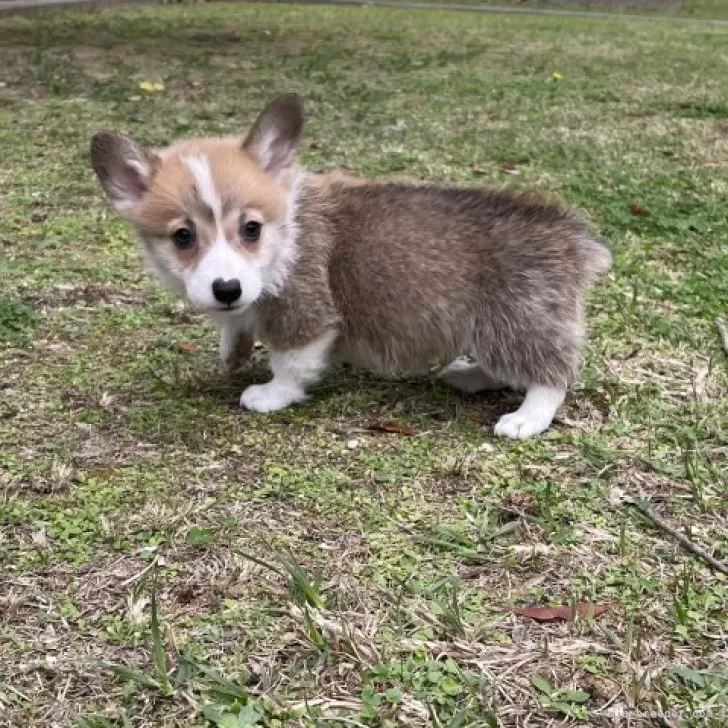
left=91, top=94, right=611, bottom=439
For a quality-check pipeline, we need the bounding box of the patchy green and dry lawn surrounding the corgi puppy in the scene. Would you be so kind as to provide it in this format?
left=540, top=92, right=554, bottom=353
left=0, top=5, right=728, bottom=728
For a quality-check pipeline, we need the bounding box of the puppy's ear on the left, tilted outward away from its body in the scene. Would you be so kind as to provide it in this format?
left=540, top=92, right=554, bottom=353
left=91, top=132, right=159, bottom=214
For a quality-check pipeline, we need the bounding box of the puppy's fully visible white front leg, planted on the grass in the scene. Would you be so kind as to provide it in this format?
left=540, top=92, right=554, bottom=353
left=240, top=331, right=337, bottom=412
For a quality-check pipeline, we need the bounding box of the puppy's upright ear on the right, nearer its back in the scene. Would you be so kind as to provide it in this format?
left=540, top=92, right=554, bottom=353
left=243, top=94, right=303, bottom=178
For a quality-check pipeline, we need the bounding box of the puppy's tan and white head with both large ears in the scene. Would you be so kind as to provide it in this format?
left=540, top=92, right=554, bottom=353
left=91, top=94, right=303, bottom=316
